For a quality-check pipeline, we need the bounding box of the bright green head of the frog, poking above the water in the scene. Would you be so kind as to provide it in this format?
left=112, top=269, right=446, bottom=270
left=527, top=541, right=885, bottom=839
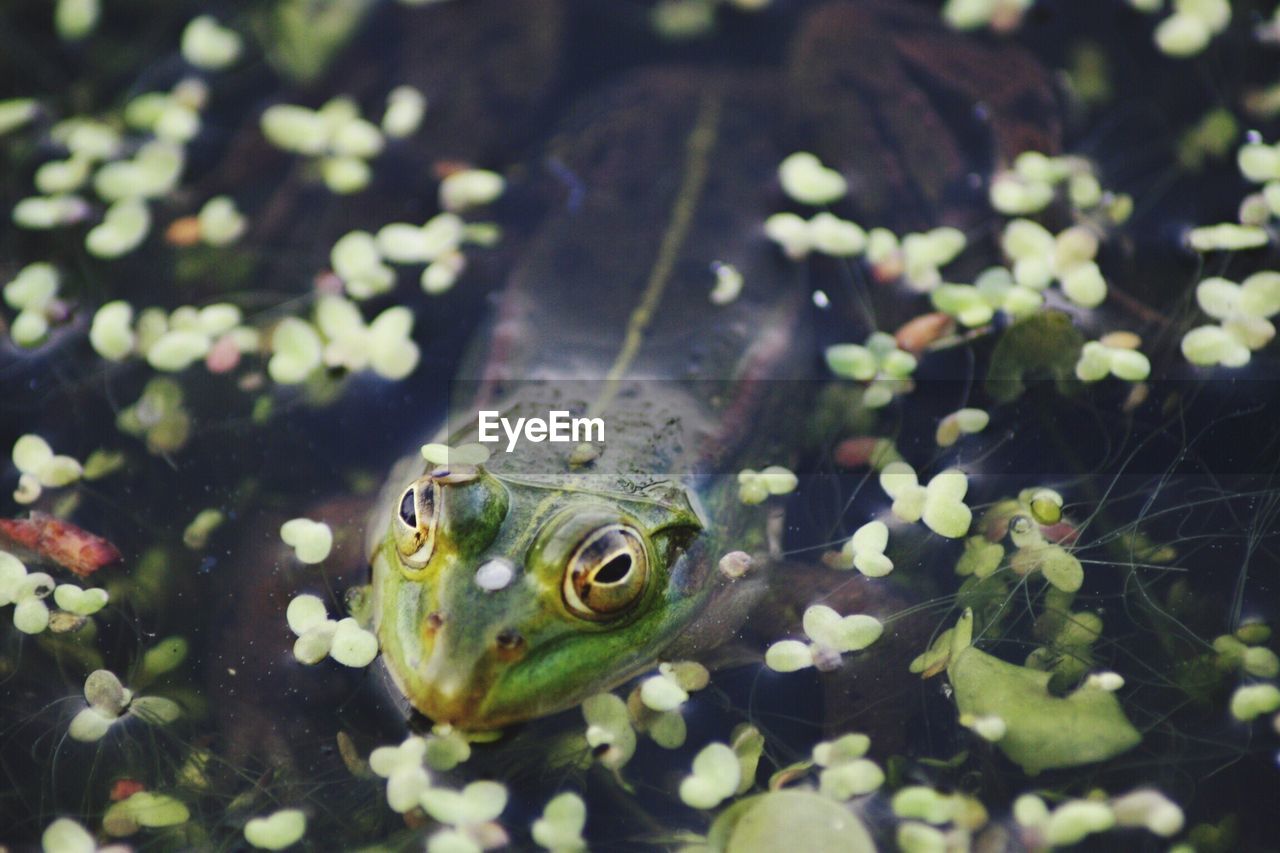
left=372, top=466, right=708, bottom=730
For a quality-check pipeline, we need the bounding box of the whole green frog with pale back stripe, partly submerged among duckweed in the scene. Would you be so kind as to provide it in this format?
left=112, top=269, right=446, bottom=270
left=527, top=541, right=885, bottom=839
left=369, top=4, right=1054, bottom=730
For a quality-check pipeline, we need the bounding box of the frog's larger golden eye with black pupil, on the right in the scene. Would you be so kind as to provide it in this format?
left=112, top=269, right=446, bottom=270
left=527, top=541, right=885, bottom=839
left=563, top=524, right=649, bottom=620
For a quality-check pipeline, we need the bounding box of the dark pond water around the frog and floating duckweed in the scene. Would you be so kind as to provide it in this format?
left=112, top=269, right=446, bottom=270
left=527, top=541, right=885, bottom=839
left=0, top=0, right=1280, bottom=850
